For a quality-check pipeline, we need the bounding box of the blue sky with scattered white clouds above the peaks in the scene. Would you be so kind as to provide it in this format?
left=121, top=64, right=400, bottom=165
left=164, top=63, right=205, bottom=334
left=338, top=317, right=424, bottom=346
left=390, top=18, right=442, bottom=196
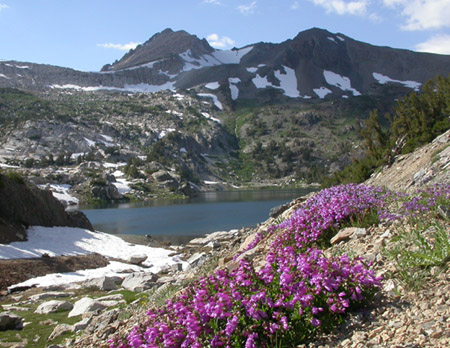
left=0, top=0, right=450, bottom=71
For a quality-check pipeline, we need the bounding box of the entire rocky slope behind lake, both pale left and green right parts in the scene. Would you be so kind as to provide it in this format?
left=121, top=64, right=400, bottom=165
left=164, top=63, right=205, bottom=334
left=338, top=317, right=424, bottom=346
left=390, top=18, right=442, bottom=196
left=0, top=85, right=394, bottom=204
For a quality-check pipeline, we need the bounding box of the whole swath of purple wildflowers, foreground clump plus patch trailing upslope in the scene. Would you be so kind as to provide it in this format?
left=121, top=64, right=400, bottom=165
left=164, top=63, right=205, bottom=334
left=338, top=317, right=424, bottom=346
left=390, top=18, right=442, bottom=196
left=110, top=185, right=390, bottom=348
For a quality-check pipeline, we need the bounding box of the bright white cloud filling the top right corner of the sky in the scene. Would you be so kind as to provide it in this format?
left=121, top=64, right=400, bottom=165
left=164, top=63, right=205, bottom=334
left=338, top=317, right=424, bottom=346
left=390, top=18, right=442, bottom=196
left=383, top=0, right=450, bottom=31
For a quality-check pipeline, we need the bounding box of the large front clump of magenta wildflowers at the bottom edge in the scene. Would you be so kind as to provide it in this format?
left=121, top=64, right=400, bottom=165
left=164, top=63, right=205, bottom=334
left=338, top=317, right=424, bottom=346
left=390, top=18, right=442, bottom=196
left=110, top=248, right=379, bottom=348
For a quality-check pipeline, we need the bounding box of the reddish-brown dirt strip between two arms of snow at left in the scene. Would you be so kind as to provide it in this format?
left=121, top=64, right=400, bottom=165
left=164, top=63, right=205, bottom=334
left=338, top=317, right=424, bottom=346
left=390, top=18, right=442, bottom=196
left=0, top=254, right=108, bottom=294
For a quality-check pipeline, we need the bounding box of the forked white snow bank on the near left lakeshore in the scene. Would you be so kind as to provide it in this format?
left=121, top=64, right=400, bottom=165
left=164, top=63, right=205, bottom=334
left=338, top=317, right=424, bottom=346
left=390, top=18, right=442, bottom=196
left=0, top=226, right=187, bottom=288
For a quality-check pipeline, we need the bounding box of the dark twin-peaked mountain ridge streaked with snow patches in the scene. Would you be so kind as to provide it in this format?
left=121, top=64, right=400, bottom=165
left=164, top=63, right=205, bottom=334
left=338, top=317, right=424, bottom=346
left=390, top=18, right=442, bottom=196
left=0, top=28, right=450, bottom=105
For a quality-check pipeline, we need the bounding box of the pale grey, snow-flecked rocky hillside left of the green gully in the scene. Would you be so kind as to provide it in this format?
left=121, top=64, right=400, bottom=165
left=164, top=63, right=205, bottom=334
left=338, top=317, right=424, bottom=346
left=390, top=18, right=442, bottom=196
left=0, top=90, right=243, bottom=202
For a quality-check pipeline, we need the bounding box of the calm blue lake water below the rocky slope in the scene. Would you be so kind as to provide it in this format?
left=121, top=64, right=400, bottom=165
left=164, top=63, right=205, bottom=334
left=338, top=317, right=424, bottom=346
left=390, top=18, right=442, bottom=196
left=83, top=189, right=312, bottom=240
